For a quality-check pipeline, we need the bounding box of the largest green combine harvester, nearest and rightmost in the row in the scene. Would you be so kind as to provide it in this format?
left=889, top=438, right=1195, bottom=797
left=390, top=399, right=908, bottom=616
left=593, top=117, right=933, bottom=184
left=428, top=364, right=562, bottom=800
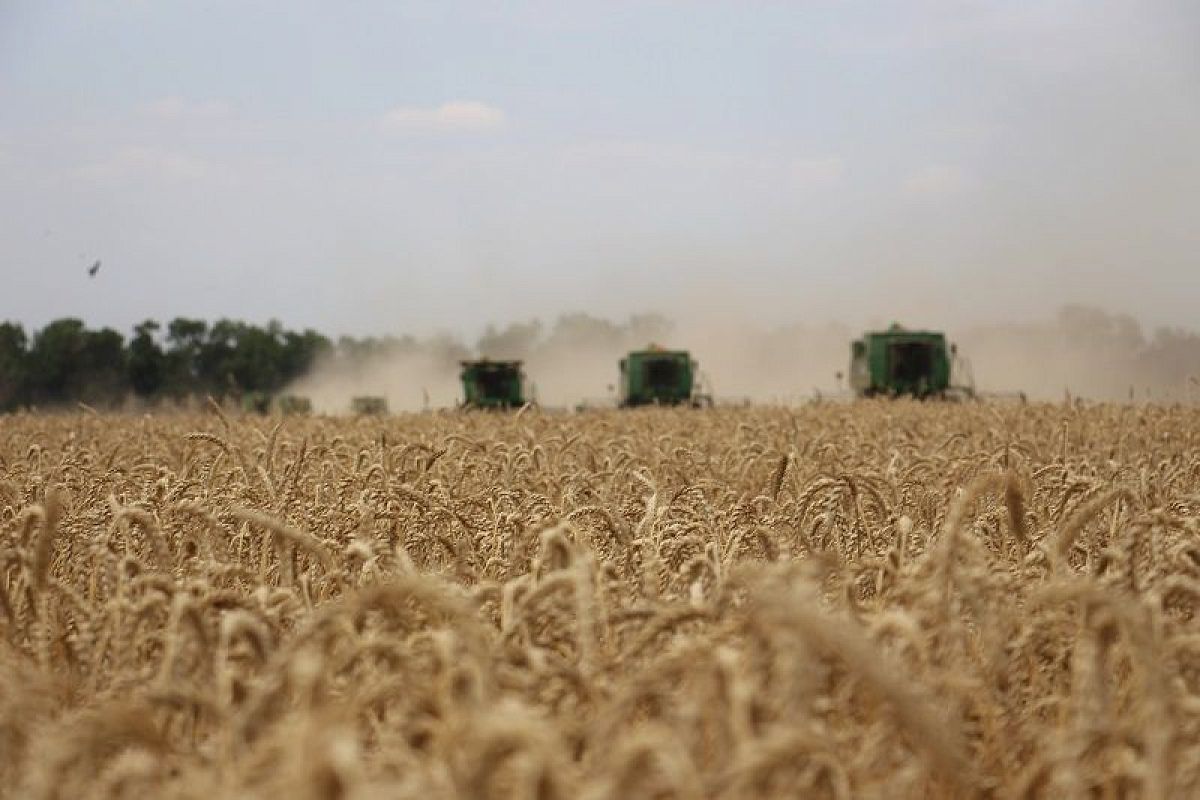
left=850, top=324, right=973, bottom=398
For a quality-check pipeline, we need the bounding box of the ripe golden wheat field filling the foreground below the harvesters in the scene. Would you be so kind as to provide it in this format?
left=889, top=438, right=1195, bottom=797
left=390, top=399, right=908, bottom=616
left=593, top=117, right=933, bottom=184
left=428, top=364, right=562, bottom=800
left=0, top=402, right=1200, bottom=800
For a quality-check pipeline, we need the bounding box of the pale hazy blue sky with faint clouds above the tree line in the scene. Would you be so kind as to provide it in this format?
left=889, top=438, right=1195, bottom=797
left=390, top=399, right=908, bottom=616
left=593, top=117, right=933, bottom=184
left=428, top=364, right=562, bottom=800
left=0, top=0, right=1200, bottom=335
